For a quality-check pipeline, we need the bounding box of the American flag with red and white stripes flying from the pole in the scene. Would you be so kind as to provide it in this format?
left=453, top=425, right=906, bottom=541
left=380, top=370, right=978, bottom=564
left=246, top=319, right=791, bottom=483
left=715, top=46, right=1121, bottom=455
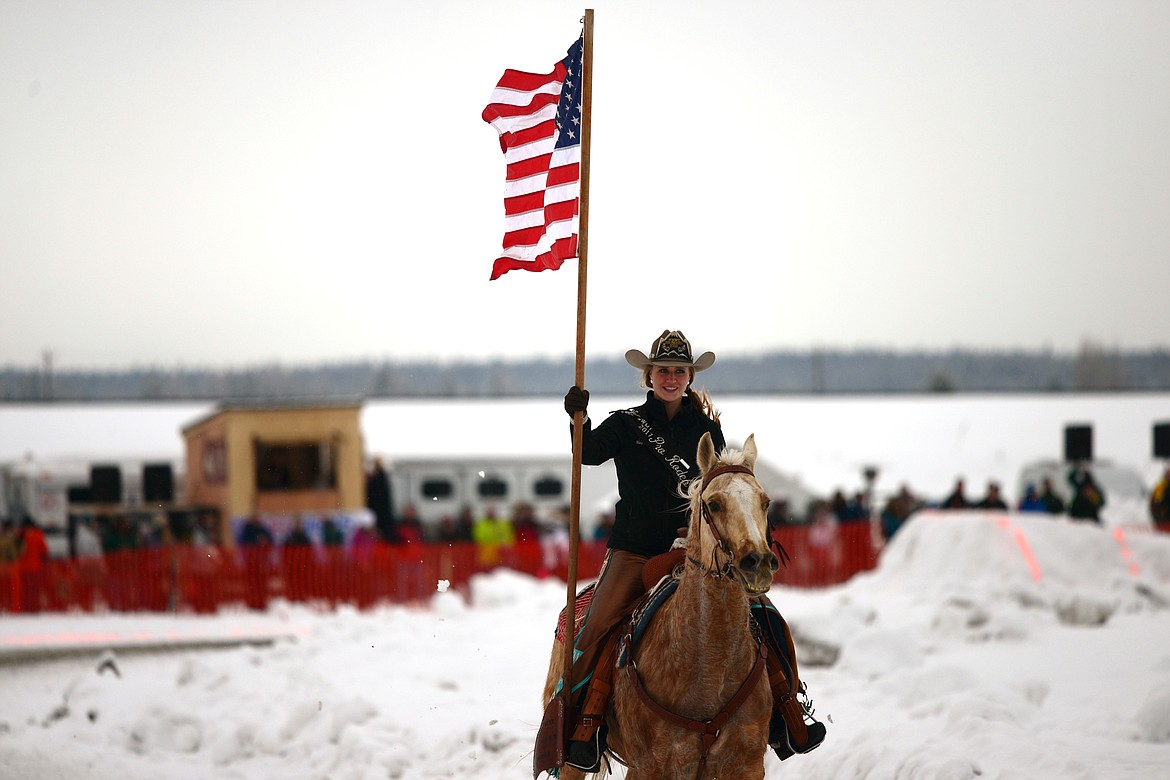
left=483, top=39, right=584, bottom=279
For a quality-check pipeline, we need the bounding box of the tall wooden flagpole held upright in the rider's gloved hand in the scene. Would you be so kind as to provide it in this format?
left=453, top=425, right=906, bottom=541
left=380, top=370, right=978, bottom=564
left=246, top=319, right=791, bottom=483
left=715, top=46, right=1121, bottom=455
left=562, top=8, right=593, bottom=709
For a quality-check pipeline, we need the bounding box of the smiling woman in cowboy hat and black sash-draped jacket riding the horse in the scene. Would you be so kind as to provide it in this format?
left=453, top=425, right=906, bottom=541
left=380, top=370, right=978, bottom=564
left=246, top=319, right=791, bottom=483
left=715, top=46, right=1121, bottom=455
left=542, top=330, right=825, bottom=772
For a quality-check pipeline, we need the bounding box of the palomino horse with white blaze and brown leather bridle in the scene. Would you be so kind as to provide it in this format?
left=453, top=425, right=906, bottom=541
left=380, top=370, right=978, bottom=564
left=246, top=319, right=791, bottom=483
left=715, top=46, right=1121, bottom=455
left=544, top=434, right=779, bottom=780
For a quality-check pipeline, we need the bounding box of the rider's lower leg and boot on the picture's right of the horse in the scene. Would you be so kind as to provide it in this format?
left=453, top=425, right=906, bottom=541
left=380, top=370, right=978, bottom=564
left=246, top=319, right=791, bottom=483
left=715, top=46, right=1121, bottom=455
left=751, top=598, right=826, bottom=761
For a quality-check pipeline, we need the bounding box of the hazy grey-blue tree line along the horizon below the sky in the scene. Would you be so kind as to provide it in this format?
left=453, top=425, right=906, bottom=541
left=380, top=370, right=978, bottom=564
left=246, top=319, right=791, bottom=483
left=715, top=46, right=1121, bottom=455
left=0, top=343, right=1170, bottom=402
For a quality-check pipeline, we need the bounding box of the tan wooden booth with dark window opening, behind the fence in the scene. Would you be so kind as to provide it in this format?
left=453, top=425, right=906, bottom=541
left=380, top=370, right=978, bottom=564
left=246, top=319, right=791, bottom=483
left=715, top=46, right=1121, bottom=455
left=183, top=403, right=365, bottom=544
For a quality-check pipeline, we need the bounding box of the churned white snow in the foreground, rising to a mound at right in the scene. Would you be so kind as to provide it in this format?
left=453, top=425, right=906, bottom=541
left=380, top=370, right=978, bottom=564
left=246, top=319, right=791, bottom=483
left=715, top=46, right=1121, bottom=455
left=0, top=512, right=1170, bottom=780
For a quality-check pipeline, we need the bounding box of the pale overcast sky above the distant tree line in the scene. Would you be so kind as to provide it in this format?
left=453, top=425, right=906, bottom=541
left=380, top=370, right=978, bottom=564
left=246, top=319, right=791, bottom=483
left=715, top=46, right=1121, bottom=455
left=0, top=0, right=1170, bottom=367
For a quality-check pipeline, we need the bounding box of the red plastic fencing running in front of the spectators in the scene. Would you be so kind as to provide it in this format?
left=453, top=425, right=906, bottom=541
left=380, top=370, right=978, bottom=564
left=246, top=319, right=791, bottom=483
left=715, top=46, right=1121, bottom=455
left=0, top=524, right=878, bottom=613
